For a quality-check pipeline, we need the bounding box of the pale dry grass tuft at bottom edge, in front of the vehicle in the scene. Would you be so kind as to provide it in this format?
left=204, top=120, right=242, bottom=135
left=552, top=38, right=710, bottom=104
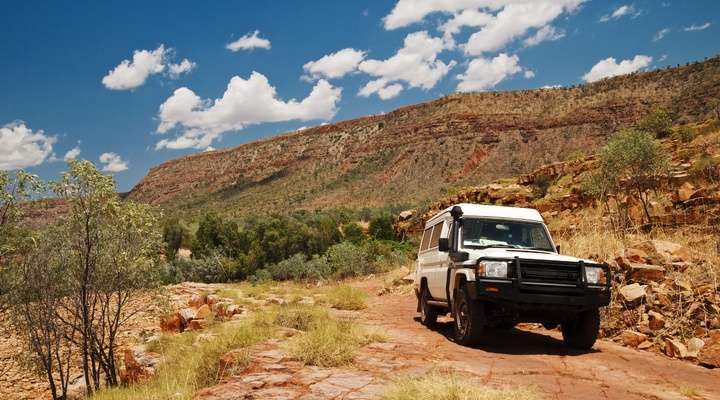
left=380, top=373, right=539, bottom=400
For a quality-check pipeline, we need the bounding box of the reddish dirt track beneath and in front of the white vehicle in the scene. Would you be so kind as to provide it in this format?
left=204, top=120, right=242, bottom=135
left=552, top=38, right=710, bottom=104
left=365, top=294, right=720, bottom=400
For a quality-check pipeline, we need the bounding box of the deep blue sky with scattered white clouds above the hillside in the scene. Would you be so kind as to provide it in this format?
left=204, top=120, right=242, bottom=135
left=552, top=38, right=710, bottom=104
left=0, top=0, right=720, bottom=191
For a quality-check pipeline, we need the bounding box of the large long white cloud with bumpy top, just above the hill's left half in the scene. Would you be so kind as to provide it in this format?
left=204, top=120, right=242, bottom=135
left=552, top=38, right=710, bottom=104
left=155, top=72, right=342, bottom=149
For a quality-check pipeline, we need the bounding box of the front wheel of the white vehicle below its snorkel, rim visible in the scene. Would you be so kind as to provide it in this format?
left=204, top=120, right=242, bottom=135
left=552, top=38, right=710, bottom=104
left=453, top=285, right=485, bottom=346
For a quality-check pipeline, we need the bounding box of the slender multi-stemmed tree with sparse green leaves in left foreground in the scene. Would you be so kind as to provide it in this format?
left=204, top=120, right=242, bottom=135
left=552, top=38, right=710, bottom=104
left=51, top=160, right=162, bottom=395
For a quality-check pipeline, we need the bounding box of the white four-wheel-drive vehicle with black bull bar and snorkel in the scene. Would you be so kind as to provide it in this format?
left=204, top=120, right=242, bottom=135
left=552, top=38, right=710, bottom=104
left=415, top=204, right=610, bottom=349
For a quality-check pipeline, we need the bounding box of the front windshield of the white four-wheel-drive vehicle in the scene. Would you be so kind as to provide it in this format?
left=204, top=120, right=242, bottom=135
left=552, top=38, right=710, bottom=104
left=462, top=218, right=555, bottom=251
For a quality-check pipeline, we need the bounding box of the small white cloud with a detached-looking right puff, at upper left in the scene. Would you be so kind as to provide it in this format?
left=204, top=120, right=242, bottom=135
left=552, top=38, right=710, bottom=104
left=102, top=44, right=195, bottom=90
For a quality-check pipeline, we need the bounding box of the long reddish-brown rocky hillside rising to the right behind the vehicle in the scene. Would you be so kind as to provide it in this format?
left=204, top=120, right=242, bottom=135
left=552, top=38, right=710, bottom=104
left=129, top=57, right=720, bottom=215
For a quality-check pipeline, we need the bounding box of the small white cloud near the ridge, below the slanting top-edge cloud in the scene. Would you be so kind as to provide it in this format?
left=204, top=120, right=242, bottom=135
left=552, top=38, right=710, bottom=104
left=457, top=53, right=522, bottom=92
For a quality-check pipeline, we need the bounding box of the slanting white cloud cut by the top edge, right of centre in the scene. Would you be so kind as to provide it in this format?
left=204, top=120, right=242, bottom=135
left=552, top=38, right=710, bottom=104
left=464, top=0, right=582, bottom=55
